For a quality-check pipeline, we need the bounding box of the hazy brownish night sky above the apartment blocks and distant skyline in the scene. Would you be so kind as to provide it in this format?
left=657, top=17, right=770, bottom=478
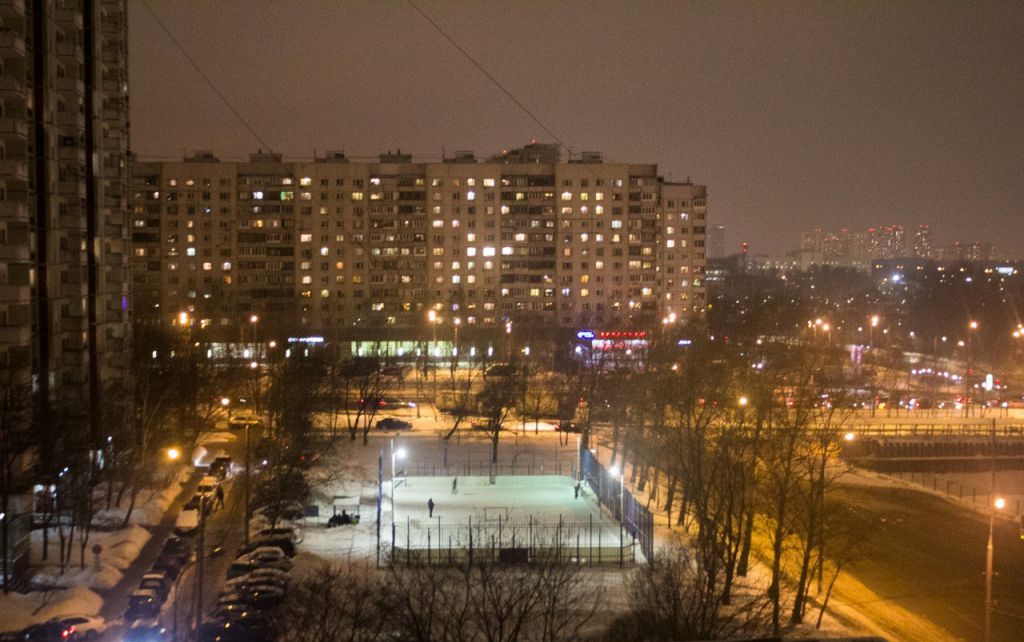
left=129, top=0, right=1024, bottom=257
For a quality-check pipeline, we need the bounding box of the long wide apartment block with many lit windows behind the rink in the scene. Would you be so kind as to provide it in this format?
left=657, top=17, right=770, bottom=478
left=132, top=143, right=707, bottom=338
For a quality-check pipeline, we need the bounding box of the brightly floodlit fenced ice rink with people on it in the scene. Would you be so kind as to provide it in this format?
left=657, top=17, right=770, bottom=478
left=381, top=474, right=636, bottom=564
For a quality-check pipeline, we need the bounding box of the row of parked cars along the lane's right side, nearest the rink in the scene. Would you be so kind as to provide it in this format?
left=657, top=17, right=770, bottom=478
left=199, top=525, right=302, bottom=642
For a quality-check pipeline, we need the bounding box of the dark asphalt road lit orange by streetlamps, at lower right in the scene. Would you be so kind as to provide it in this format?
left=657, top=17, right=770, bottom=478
left=831, top=486, right=1024, bottom=641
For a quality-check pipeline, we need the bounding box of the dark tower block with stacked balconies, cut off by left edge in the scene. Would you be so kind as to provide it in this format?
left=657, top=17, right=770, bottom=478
left=0, top=0, right=130, bottom=577
